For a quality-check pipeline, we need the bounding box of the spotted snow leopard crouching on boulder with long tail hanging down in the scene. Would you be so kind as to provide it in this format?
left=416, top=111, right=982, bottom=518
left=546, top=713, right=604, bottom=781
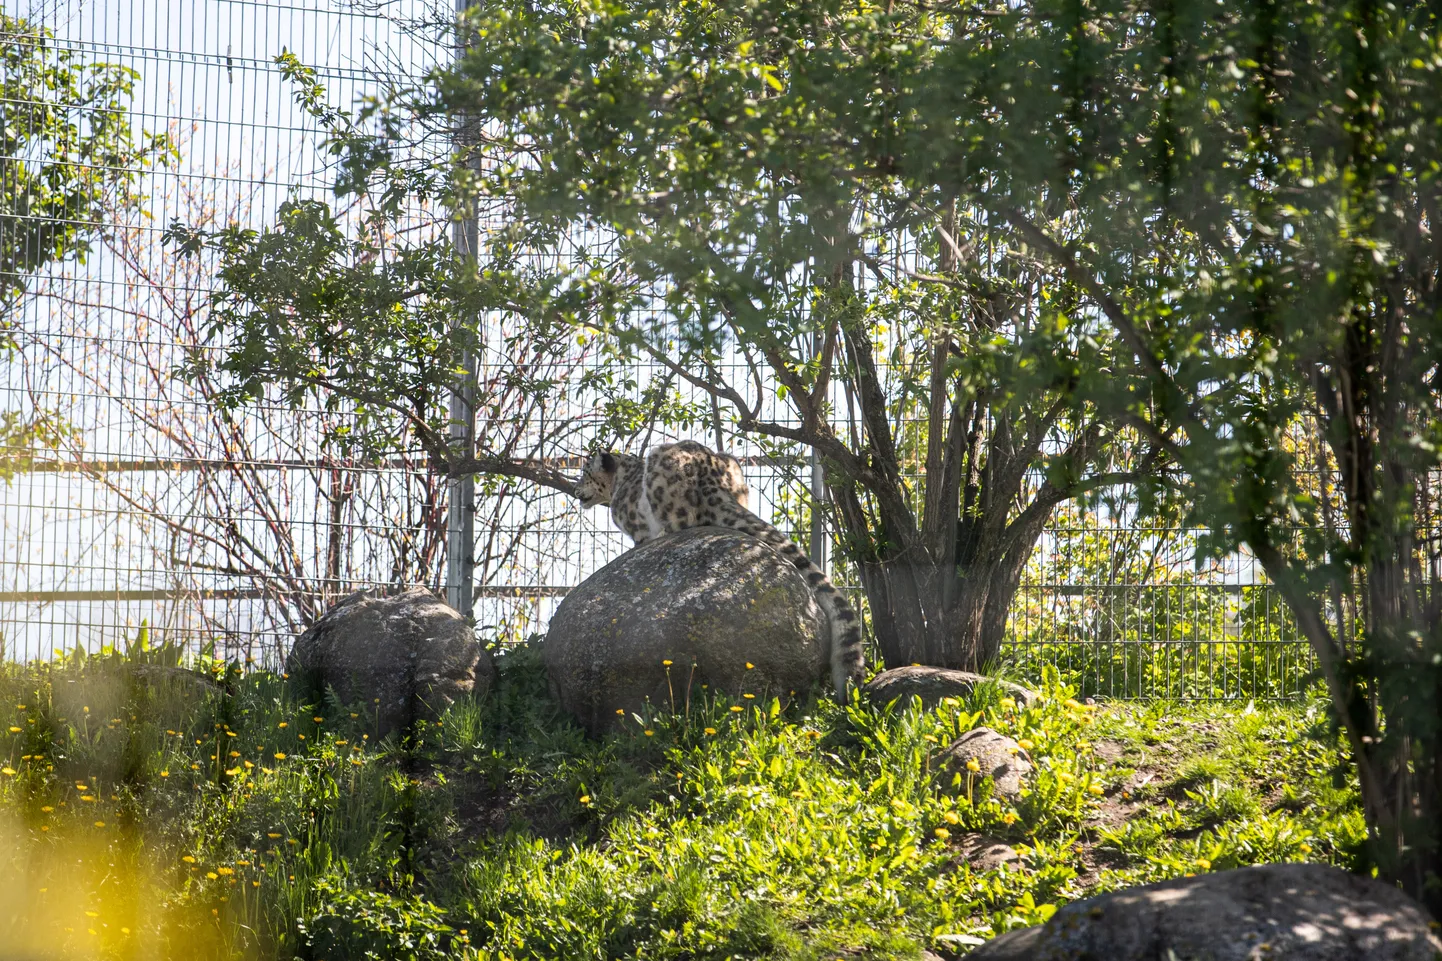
left=575, top=440, right=865, bottom=704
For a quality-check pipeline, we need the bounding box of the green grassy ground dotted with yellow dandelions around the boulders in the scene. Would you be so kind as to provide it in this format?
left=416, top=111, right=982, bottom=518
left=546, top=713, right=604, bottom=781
left=0, top=634, right=1363, bottom=961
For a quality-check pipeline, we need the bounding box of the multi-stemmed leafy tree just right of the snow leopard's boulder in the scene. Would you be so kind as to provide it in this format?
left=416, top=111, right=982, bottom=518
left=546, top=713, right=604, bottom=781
left=312, top=0, right=1159, bottom=668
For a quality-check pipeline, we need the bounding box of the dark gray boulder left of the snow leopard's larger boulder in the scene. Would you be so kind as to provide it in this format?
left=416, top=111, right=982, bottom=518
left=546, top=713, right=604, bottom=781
left=287, top=587, right=496, bottom=736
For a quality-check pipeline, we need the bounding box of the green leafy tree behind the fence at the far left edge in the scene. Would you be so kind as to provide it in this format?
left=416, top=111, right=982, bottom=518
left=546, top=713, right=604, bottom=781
left=0, top=13, right=170, bottom=476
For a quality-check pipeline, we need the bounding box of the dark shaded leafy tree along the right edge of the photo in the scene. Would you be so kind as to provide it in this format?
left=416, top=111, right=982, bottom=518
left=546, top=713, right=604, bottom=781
left=917, top=1, right=1442, bottom=912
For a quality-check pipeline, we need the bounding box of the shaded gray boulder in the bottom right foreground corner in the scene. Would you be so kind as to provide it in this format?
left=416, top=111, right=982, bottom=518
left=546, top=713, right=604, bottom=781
left=966, top=864, right=1442, bottom=961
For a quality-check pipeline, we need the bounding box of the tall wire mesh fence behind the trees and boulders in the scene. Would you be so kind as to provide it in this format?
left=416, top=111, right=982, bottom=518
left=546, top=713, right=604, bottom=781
left=0, top=0, right=1309, bottom=697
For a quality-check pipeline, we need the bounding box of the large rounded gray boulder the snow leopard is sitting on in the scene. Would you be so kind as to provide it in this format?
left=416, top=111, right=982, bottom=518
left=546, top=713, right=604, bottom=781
left=544, top=527, right=831, bottom=734
